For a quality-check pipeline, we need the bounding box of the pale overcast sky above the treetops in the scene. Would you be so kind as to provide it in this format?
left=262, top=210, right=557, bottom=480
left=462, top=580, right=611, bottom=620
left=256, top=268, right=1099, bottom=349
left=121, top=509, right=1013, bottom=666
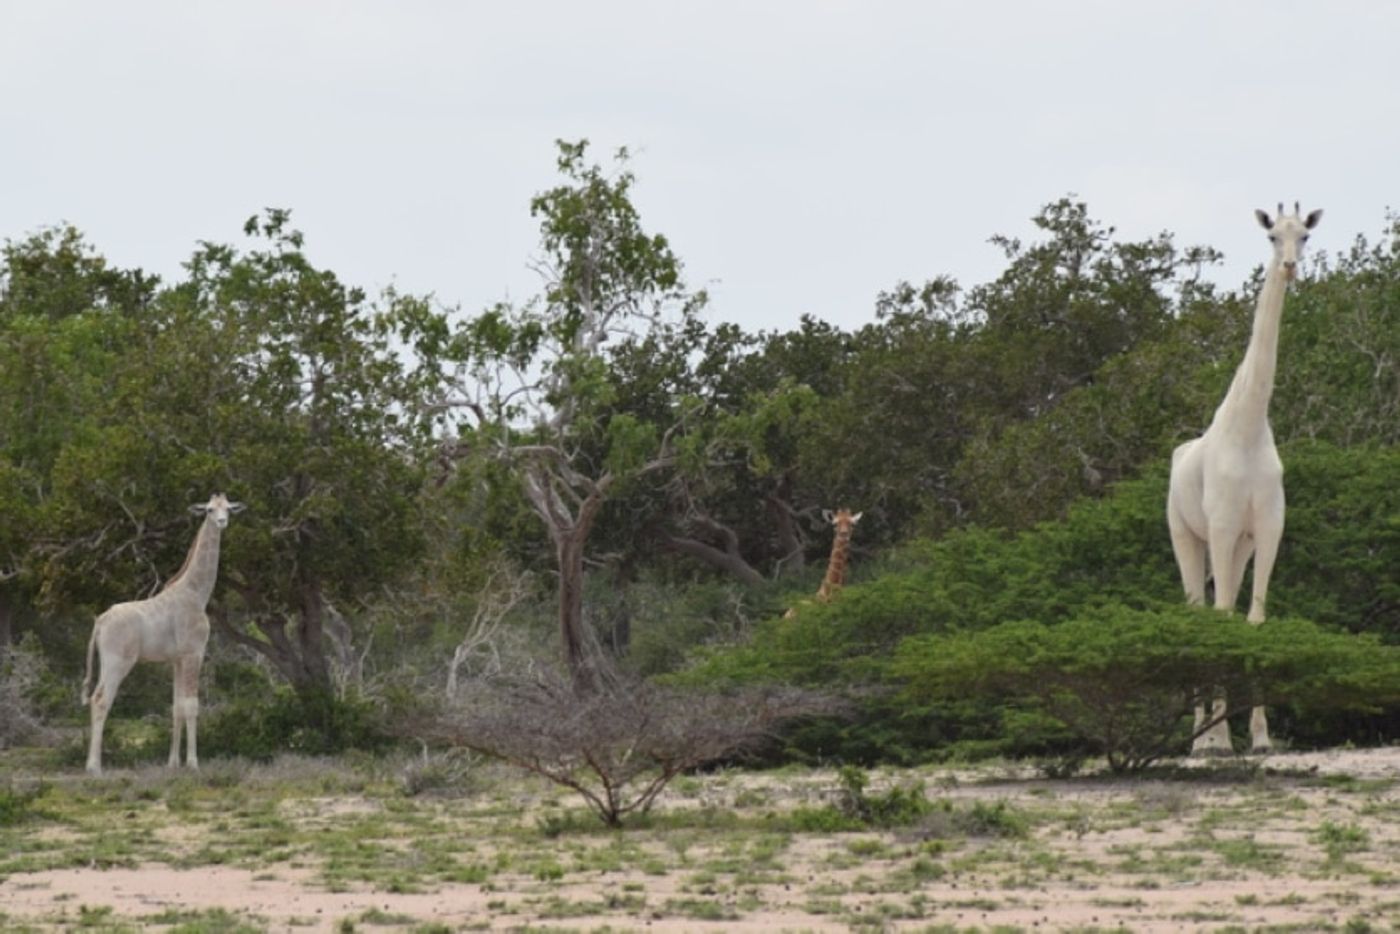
left=0, top=0, right=1400, bottom=329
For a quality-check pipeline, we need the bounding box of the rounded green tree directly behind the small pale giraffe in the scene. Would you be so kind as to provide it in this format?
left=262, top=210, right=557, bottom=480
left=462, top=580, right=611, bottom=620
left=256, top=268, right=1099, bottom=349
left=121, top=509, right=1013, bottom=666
left=162, top=210, right=442, bottom=708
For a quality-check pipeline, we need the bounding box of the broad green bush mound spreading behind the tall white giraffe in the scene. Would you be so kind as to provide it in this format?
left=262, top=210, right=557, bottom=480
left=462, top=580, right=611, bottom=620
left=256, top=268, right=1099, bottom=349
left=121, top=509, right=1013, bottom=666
left=680, top=441, right=1400, bottom=769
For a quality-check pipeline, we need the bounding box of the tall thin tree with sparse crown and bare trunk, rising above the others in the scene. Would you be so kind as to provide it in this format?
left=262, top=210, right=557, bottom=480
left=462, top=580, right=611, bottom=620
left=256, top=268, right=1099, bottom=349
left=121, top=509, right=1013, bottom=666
left=445, top=141, right=706, bottom=685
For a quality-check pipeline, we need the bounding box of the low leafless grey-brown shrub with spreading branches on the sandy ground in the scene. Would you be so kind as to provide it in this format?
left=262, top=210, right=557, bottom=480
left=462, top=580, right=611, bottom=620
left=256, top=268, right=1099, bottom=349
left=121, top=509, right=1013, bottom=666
left=419, top=667, right=841, bottom=826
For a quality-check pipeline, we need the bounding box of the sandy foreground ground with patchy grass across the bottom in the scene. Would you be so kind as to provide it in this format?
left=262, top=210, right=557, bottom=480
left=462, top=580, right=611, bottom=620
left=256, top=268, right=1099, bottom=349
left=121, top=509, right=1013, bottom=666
left=0, top=749, right=1400, bottom=931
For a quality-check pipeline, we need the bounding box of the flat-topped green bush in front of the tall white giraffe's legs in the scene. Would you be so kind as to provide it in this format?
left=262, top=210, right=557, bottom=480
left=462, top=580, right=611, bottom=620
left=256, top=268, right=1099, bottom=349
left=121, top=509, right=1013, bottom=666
left=892, top=606, right=1400, bottom=772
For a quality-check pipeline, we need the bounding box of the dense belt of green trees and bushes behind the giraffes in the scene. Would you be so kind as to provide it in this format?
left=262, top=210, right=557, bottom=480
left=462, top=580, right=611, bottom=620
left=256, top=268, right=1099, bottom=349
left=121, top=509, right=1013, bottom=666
left=0, top=143, right=1400, bottom=763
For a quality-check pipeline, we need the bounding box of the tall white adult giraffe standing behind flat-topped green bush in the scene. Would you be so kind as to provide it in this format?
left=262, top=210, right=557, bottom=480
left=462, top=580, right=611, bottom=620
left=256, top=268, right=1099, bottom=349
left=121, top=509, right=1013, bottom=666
left=1166, top=203, right=1322, bottom=755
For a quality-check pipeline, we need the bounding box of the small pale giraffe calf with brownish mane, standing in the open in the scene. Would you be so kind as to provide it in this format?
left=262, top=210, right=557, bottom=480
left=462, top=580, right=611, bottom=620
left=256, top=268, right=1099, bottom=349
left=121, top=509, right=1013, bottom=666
left=83, top=493, right=244, bottom=774
